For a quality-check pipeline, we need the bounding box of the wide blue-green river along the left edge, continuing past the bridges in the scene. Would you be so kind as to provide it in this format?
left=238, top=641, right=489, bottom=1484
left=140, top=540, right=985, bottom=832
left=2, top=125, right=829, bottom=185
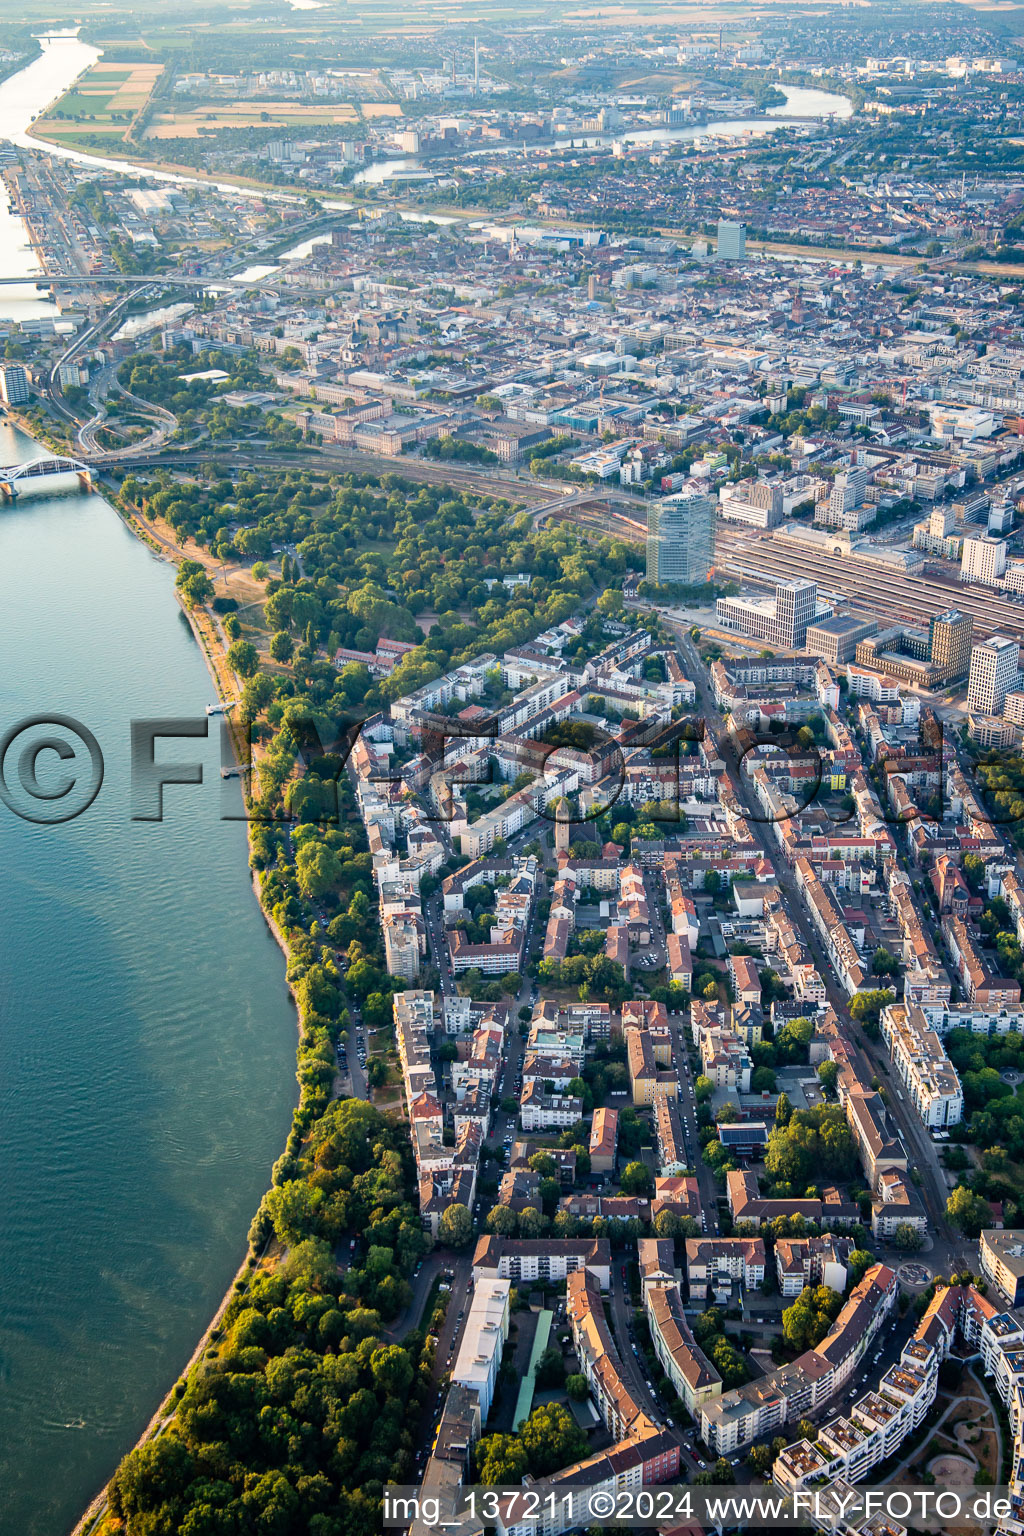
left=0, top=45, right=296, bottom=1536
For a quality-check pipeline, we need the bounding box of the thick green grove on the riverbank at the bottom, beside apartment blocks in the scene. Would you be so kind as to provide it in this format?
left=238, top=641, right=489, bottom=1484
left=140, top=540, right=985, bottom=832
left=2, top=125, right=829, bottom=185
left=111, top=1100, right=430, bottom=1536
